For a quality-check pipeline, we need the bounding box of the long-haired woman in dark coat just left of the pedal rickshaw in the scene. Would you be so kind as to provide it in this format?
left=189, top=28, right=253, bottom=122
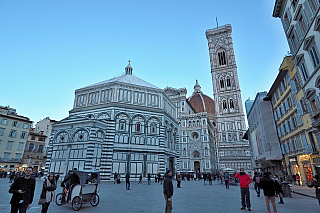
left=40, top=173, right=57, bottom=213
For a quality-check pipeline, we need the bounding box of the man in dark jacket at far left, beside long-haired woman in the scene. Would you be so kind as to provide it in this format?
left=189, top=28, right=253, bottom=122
left=9, top=167, right=36, bottom=213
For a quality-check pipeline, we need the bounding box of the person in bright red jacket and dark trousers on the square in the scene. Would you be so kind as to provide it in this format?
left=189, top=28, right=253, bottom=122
left=235, top=168, right=251, bottom=211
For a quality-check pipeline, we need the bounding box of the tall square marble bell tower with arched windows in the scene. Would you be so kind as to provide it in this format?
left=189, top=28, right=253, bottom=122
left=206, top=24, right=251, bottom=169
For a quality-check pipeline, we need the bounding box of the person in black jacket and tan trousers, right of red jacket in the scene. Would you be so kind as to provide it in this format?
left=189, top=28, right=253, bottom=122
left=259, top=172, right=277, bottom=213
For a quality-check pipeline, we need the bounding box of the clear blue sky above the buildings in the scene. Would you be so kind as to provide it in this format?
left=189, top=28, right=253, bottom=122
left=0, top=0, right=289, bottom=123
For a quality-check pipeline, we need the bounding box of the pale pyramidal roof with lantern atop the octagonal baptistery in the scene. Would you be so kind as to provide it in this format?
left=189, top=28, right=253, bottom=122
left=80, top=62, right=160, bottom=89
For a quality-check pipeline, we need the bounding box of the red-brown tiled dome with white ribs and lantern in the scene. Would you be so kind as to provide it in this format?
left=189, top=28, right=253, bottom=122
left=188, top=80, right=215, bottom=114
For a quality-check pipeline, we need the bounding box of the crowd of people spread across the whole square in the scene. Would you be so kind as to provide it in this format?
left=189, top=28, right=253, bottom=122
left=1, top=167, right=320, bottom=213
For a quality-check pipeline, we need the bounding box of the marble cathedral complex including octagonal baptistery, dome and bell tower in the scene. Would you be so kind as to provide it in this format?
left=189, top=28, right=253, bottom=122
left=45, top=25, right=251, bottom=180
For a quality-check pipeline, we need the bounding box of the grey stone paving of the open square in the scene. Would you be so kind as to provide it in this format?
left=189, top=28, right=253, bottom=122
left=0, top=178, right=320, bottom=213
